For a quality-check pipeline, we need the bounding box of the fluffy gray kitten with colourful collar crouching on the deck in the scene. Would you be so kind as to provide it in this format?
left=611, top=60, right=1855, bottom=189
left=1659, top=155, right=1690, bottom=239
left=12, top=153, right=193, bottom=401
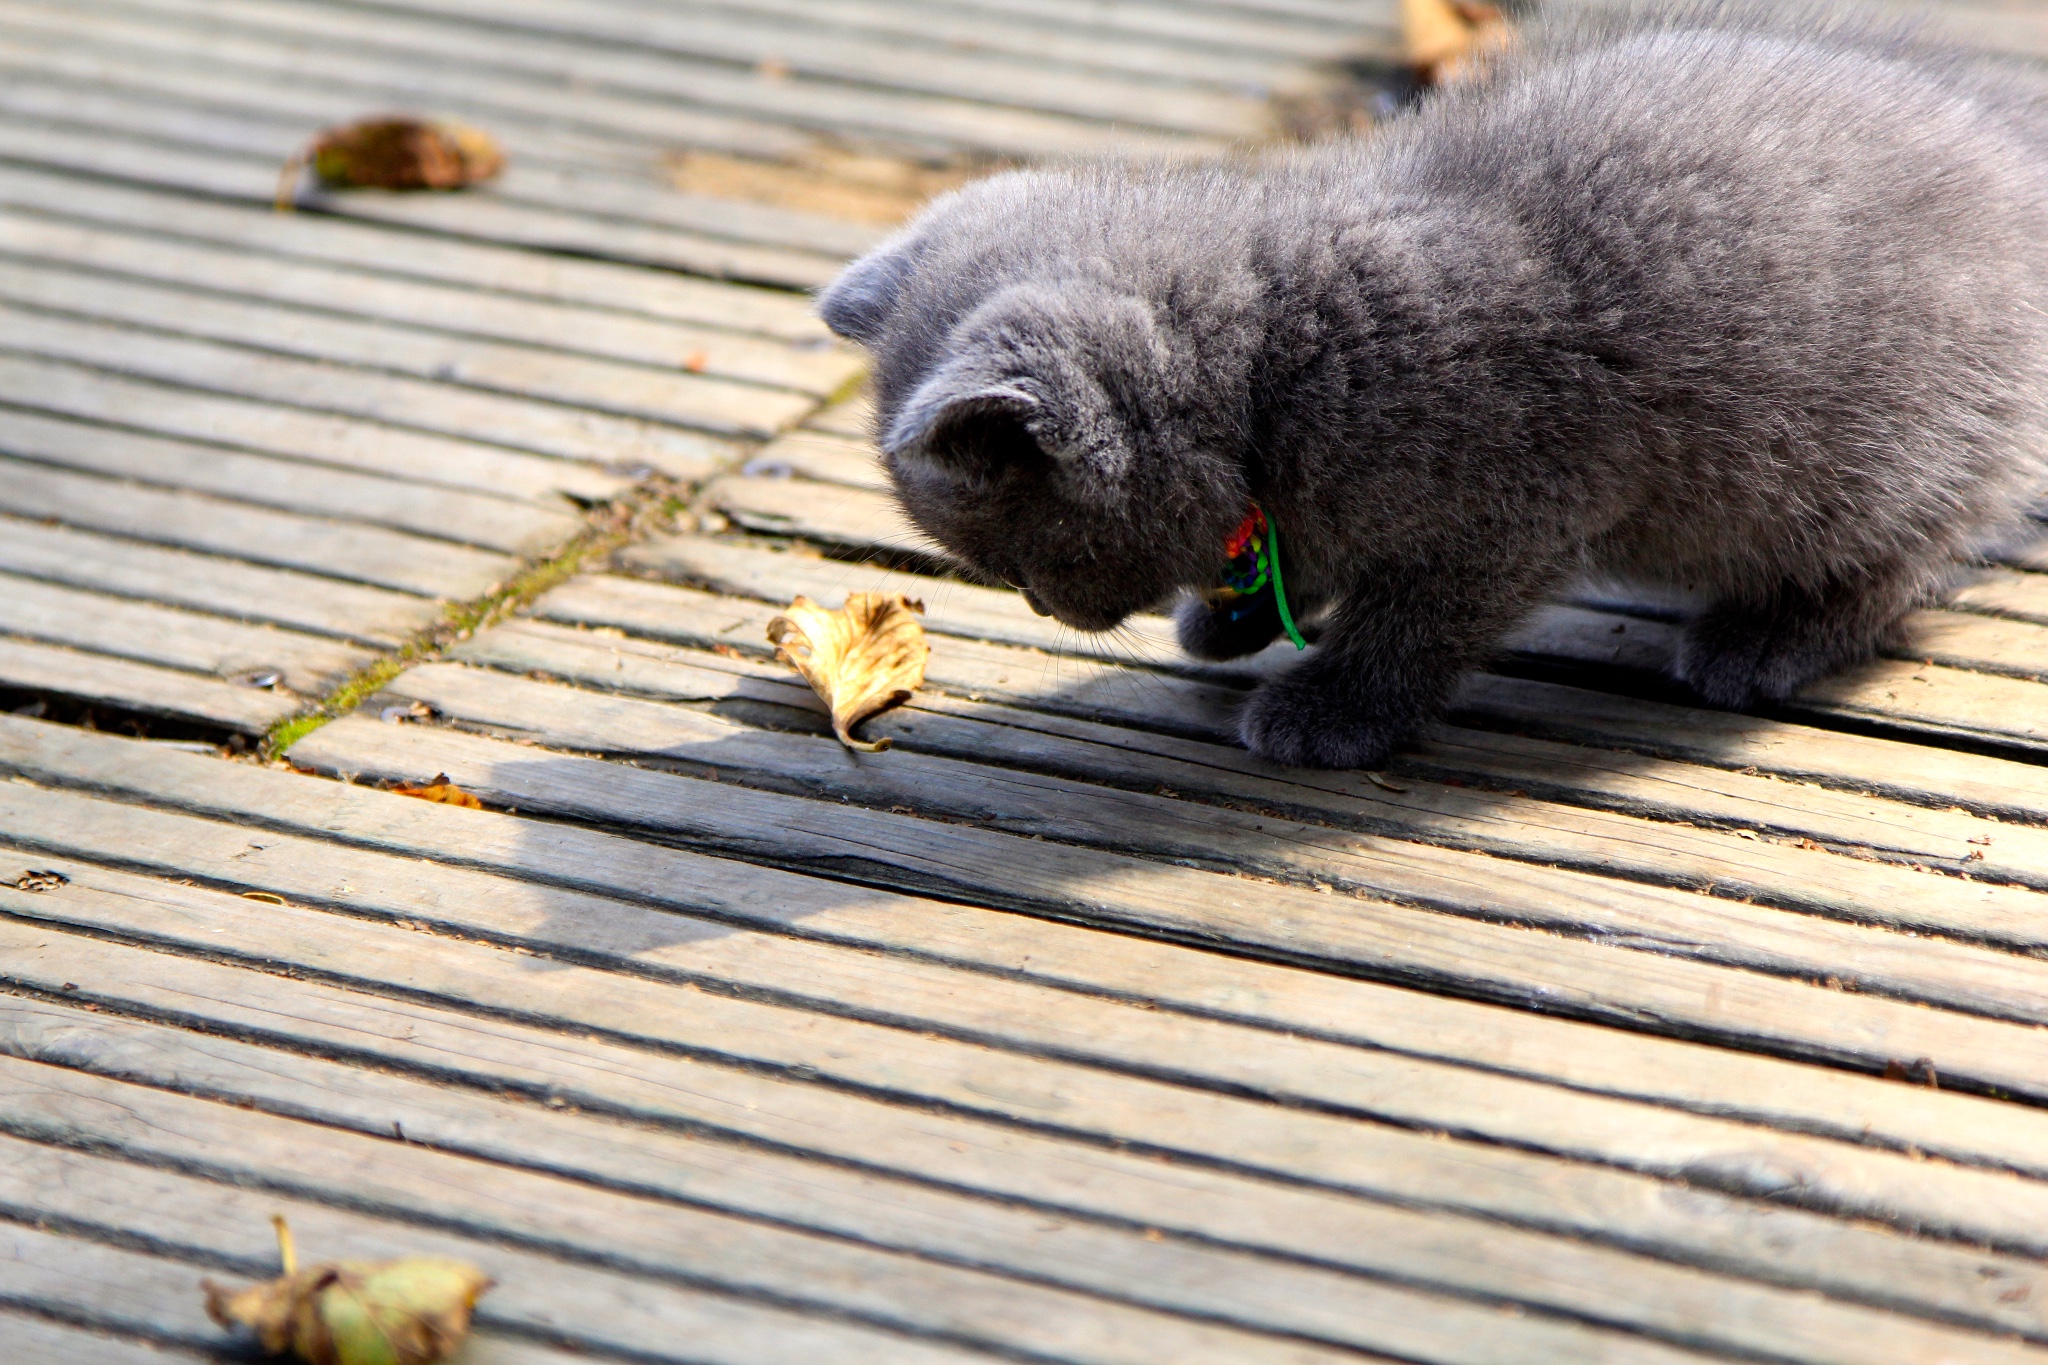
left=819, top=6, right=2048, bottom=767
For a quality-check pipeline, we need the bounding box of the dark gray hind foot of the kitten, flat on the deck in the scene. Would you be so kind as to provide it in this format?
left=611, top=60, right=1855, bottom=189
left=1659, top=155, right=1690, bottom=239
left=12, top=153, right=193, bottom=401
left=1677, top=565, right=1929, bottom=708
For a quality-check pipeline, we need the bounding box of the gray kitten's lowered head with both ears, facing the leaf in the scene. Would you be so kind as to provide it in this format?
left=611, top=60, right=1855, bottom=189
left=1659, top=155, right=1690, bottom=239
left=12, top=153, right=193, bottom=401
left=819, top=172, right=1257, bottom=630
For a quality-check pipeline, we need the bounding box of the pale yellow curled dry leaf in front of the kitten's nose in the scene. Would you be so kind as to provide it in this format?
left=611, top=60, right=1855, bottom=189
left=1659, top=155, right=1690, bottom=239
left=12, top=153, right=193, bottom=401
left=768, top=591, right=932, bottom=753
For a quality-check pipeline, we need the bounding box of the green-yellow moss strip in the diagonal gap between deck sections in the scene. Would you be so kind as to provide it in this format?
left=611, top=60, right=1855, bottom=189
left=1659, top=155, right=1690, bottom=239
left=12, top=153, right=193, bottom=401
left=262, top=479, right=690, bottom=759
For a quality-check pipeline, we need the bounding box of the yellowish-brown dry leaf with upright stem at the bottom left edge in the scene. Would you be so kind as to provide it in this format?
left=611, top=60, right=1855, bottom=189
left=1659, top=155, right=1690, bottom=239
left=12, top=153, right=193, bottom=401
left=201, top=1218, right=492, bottom=1365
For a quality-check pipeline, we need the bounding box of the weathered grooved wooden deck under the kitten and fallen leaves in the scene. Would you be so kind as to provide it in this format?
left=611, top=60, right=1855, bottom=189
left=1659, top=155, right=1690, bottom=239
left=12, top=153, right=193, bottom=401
left=0, top=0, right=2048, bottom=1365
